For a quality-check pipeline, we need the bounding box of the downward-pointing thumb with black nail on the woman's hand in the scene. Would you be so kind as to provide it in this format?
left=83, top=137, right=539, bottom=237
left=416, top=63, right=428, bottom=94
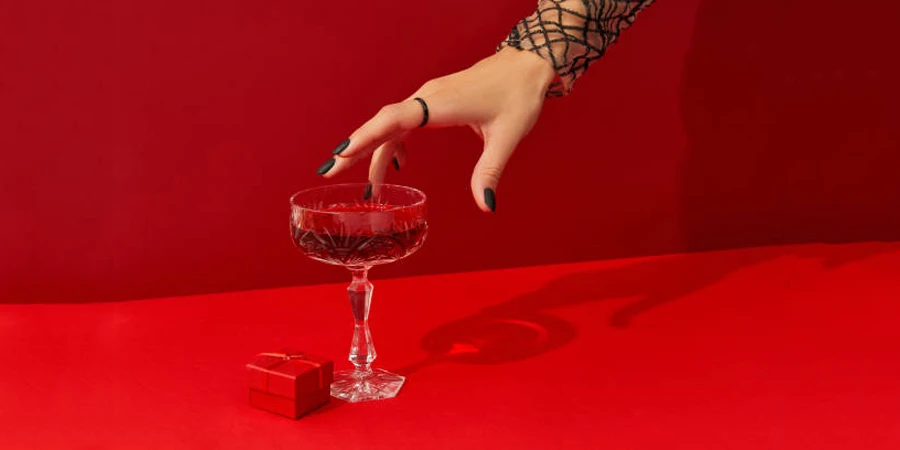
left=472, top=124, right=522, bottom=212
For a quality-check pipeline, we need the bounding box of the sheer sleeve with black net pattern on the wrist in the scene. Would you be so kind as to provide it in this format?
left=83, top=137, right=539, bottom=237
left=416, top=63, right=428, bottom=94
left=497, top=0, right=654, bottom=97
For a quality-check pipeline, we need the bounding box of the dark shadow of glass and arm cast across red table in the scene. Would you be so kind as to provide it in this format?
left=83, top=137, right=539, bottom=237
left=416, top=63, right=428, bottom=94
left=399, top=243, right=900, bottom=374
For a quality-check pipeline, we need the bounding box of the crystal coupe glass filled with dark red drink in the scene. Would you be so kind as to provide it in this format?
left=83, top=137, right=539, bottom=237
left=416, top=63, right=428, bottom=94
left=291, top=183, right=428, bottom=402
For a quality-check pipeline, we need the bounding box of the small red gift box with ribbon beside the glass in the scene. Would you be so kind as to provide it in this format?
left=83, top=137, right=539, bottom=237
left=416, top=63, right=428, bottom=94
left=247, top=352, right=334, bottom=419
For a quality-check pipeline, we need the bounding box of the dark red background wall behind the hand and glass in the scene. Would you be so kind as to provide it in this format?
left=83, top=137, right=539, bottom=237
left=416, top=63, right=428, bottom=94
left=0, top=0, right=900, bottom=302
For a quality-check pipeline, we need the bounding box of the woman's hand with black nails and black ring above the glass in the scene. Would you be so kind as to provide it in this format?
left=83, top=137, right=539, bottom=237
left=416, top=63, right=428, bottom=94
left=319, top=48, right=556, bottom=211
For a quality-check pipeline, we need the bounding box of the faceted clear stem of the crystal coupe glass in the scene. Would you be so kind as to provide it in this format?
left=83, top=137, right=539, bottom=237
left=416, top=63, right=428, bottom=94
left=347, top=268, right=377, bottom=378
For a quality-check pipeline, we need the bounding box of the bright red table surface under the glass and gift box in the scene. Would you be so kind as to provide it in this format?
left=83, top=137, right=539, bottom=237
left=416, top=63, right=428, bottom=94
left=0, top=243, right=900, bottom=450
